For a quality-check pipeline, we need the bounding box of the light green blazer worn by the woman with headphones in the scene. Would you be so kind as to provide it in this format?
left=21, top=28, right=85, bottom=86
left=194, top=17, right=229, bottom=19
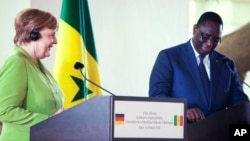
left=0, top=46, right=64, bottom=141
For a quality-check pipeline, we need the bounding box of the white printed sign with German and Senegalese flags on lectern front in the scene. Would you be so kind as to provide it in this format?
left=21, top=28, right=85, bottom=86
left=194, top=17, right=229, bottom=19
left=113, top=98, right=186, bottom=140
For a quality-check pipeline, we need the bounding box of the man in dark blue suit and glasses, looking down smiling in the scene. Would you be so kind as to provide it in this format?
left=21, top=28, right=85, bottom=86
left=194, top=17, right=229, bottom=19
left=149, top=12, right=249, bottom=122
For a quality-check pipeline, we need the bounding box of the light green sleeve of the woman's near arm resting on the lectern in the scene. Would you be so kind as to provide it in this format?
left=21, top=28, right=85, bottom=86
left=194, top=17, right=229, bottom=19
left=0, top=56, right=48, bottom=127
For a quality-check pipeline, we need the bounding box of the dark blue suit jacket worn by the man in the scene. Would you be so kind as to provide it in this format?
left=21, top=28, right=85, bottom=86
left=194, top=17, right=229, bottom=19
left=149, top=41, right=248, bottom=116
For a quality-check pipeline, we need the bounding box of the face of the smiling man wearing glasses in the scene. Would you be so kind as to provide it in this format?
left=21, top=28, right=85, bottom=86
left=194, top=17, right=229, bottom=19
left=192, top=21, right=222, bottom=56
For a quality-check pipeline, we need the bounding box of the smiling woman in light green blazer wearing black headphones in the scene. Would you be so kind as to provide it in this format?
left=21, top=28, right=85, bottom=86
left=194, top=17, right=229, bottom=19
left=0, top=9, right=64, bottom=141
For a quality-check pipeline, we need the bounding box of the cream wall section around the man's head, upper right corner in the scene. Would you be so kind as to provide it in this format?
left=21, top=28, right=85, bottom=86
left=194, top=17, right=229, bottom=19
left=190, top=0, right=250, bottom=35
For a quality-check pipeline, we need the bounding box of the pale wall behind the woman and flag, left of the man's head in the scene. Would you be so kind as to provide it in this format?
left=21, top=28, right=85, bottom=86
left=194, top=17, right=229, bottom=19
left=0, top=0, right=189, bottom=96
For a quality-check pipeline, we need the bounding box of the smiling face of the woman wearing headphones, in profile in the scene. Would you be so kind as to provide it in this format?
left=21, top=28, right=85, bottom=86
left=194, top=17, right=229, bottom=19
left=34, top=28, right=57, bottom=59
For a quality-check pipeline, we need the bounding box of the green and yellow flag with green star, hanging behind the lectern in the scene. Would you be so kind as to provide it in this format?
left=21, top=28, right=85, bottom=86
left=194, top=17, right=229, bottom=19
left=53, top=0, right=102, bottom=108
